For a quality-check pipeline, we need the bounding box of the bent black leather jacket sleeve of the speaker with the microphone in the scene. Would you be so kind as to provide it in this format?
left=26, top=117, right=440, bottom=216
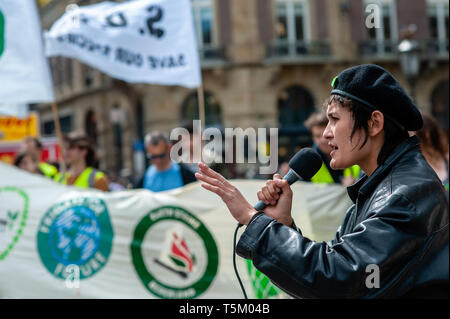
left=236, top=195, right=427, bottom=298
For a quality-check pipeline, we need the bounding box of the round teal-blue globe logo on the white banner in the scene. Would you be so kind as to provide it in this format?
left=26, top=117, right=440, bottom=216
left=37, top=198, right=113, bottom=279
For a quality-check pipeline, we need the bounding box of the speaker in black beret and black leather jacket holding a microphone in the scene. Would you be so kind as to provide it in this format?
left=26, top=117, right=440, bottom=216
left=196, top=64, right=449, bottom=298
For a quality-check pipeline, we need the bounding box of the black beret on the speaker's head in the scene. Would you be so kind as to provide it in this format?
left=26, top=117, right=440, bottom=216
left=331, top=64, right=423, bottom=131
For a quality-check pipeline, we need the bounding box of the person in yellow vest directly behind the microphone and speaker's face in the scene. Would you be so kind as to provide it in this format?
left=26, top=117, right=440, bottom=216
left=304, top=112, right=361, bottom=186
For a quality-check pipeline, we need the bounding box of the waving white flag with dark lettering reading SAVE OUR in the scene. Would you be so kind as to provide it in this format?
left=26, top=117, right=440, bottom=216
left=45, top=0, right=201, bottom=88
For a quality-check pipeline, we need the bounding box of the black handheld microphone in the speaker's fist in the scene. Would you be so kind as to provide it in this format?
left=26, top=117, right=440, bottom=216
left=253, top=148, right=322, bottom=211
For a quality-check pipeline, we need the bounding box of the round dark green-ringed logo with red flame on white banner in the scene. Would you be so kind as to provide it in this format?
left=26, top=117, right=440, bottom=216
left=131, top=206, right=219, bottom=299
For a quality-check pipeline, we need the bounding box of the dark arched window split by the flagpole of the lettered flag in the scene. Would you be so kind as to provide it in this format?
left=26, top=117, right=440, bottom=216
left=181, top=92, right=222, bottom=128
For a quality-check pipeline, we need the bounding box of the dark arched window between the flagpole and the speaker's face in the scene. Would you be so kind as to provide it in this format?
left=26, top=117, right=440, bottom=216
left=278, top=85, right=315, bottom=128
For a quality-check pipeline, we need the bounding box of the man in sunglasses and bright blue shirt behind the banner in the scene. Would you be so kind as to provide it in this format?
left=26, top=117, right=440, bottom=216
left=142, top=131, right=197, bottom=192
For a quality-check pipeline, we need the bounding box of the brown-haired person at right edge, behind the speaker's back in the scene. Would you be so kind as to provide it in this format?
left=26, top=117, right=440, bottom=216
left=416, top=114, right=449, bottom=191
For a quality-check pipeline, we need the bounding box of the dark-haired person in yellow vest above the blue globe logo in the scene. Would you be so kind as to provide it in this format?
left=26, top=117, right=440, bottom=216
left=55, top=134, right=109, bottom=191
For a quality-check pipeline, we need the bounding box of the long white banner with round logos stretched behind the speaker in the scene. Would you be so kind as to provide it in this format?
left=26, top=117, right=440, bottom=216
left=0, top=163, right=350, bottom=299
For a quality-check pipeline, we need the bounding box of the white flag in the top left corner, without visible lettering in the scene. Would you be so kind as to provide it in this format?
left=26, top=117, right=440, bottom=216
left=0, top=0, right=54, bottom=105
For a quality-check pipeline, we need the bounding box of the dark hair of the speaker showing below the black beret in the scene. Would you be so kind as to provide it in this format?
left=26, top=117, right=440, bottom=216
left=326, top=94, right=409, bottom=165
